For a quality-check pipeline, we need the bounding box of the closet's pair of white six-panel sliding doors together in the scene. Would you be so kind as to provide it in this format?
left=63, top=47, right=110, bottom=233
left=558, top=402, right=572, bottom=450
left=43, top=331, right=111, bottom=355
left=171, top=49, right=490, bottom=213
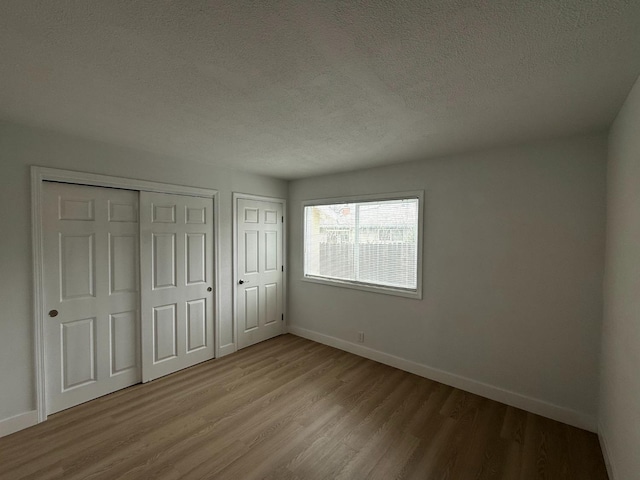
left=41, top=182, right=215, bottom=414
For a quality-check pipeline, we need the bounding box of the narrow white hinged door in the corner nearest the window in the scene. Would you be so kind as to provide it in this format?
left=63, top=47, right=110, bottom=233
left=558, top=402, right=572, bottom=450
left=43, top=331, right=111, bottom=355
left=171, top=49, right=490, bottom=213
left=235, top=198, right=284, bottom=348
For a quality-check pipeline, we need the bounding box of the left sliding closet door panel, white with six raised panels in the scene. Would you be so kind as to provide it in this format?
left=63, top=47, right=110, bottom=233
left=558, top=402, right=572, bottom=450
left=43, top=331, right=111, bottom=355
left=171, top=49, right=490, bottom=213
left=42, top=182, right=140, bottom=413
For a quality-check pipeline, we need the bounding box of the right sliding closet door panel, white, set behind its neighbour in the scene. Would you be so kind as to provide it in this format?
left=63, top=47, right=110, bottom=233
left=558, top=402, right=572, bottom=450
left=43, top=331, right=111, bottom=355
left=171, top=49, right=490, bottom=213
left=140, top=192, right=214, bottom=382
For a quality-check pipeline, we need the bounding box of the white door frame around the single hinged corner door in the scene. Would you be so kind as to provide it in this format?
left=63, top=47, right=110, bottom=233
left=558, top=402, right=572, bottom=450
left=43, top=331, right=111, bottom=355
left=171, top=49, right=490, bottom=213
left=231, top=192, right=288, bottom=350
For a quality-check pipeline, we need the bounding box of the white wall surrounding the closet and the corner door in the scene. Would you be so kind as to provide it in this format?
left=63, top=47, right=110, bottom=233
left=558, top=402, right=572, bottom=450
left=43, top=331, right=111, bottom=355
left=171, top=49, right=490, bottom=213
left=0, top=122, right=287, bottom=432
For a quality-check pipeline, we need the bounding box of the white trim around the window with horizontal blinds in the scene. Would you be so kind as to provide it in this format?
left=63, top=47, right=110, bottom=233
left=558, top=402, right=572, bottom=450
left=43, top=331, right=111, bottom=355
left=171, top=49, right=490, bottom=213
left=301, top=190, right=424, bottom=300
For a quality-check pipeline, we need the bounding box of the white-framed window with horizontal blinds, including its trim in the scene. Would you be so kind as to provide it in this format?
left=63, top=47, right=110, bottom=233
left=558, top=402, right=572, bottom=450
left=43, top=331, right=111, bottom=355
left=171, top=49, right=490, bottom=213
left=304, top=192, right=422, bottom=298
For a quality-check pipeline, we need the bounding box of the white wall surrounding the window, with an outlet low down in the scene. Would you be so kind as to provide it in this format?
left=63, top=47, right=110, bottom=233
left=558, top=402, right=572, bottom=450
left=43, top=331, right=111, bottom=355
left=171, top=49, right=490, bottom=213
left=288, top=134, right=607, bottom=430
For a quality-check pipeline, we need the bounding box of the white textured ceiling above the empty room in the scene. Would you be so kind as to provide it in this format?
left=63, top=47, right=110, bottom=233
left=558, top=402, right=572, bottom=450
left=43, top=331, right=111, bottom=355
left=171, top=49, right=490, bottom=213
left=0, top=0, right=640, bottom=178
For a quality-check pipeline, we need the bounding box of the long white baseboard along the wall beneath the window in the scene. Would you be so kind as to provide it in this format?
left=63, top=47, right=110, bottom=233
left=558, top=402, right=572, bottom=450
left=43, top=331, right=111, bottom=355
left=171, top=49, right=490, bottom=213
left=288, top=325, right=597, bottom=432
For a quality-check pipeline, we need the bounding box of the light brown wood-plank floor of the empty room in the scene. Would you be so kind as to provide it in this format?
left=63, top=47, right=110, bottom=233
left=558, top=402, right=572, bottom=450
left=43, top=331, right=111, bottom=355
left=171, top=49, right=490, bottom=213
left=0, top=335, right=607, bottom=480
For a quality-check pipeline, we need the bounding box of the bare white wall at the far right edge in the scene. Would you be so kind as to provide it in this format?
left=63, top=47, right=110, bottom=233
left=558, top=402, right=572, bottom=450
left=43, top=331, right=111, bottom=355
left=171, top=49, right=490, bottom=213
left=599, top=73, right=640, bottom=480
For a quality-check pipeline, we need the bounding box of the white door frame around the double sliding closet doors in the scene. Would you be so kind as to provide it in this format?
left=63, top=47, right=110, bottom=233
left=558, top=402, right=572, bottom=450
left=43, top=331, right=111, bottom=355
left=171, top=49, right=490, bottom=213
left=31, top=166, right=220, bottom=423
